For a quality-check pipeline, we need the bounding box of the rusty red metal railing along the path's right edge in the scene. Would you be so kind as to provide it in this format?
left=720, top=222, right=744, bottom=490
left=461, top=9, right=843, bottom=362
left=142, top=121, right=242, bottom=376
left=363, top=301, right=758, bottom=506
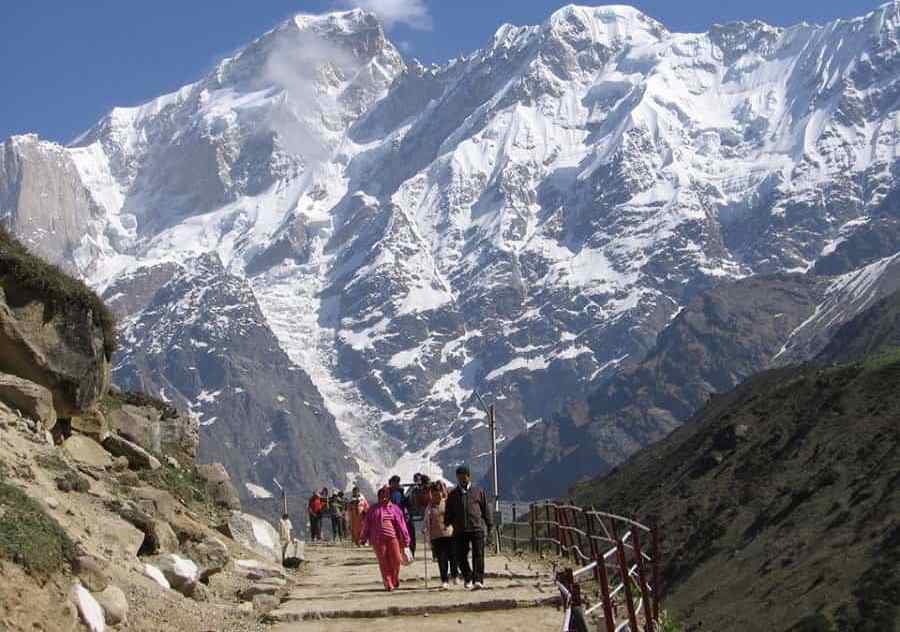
left=500, top=501, right=660, bottom=632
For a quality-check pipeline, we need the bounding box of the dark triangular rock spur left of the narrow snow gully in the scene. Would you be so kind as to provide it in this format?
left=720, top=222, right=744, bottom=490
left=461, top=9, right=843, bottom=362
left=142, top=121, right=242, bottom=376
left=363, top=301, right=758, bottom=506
left=116, top=255, right=355, bottom=514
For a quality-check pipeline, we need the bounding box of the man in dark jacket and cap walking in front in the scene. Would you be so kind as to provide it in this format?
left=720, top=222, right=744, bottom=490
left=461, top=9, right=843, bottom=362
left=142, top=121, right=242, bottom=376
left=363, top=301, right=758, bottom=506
left=444, top=465, right=494, bottom=590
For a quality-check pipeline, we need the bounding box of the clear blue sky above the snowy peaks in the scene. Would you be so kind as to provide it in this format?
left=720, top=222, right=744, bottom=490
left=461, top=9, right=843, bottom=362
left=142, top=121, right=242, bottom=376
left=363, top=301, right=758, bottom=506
left=0, top=0, right=882, bottom=142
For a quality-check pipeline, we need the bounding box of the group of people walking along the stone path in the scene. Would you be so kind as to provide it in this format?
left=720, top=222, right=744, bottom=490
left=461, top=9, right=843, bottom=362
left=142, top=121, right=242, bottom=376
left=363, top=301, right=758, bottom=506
left=283, top=465, right=493, bottom=592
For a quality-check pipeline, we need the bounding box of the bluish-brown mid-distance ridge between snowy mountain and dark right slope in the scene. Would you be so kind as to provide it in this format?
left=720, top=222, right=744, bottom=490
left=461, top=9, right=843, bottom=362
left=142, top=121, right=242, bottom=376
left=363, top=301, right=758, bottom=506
left=499, top=252, right=900, bottom=497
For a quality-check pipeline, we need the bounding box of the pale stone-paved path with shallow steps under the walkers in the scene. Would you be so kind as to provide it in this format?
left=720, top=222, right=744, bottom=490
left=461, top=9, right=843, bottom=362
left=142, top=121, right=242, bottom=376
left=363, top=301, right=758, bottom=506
left=271, top=546, right=562, bottom=632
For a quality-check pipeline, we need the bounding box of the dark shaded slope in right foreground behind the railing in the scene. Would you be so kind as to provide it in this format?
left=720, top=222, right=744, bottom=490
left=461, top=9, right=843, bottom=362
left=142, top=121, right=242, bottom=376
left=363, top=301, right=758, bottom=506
left=573, top=293, right=900, bottom=632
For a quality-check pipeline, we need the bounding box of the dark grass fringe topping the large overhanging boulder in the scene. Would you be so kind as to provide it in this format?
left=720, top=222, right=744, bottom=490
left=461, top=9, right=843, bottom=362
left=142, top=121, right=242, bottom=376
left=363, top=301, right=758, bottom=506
left=0, top=225, right=117, bottom=358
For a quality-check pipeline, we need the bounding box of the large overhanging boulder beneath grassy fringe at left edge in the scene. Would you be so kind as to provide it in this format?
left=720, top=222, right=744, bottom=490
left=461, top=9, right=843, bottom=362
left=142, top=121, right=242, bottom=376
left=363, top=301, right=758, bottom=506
left=0, top=284, right=111, bottom=418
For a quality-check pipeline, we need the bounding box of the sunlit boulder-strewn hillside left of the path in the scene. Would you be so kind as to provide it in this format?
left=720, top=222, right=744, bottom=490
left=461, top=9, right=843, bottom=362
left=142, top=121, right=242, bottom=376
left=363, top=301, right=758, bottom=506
left=0, top=231, right=306, bottom=632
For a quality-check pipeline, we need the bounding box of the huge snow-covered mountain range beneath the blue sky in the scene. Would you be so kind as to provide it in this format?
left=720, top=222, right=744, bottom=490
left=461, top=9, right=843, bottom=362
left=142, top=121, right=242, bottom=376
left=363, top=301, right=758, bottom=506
left=0, top=2, right=900, bottom=498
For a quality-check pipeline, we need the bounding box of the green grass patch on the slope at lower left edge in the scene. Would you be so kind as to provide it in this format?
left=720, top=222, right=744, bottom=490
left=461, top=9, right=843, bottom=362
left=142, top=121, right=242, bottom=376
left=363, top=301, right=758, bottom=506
left=0, top=468, right=75, bottom=577
